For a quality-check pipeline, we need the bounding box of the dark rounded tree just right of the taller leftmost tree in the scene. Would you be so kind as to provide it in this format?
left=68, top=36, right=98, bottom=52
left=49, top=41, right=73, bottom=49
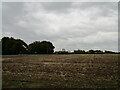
left=28, top=41, right=55, bottom=54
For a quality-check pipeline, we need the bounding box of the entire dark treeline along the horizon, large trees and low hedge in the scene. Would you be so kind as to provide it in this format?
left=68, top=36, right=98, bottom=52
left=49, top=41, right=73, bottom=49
left=0, top=37, right=118, bottom=55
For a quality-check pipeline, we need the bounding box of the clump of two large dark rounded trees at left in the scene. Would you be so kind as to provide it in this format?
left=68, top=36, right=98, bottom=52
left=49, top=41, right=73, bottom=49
left=1, top=37, right=55, bottom=55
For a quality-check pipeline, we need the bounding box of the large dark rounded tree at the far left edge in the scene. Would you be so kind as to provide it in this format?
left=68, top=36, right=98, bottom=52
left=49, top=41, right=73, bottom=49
left=1, top=37, right=28, bottom=55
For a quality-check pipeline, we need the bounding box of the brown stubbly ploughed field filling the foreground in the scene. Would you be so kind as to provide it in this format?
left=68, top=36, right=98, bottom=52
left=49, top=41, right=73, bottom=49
left=2, top=54, right=118, bottom=88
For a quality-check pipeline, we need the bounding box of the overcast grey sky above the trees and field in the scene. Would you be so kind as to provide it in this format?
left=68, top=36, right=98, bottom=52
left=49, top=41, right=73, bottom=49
left=2, top=2, right=118, bottom=51
